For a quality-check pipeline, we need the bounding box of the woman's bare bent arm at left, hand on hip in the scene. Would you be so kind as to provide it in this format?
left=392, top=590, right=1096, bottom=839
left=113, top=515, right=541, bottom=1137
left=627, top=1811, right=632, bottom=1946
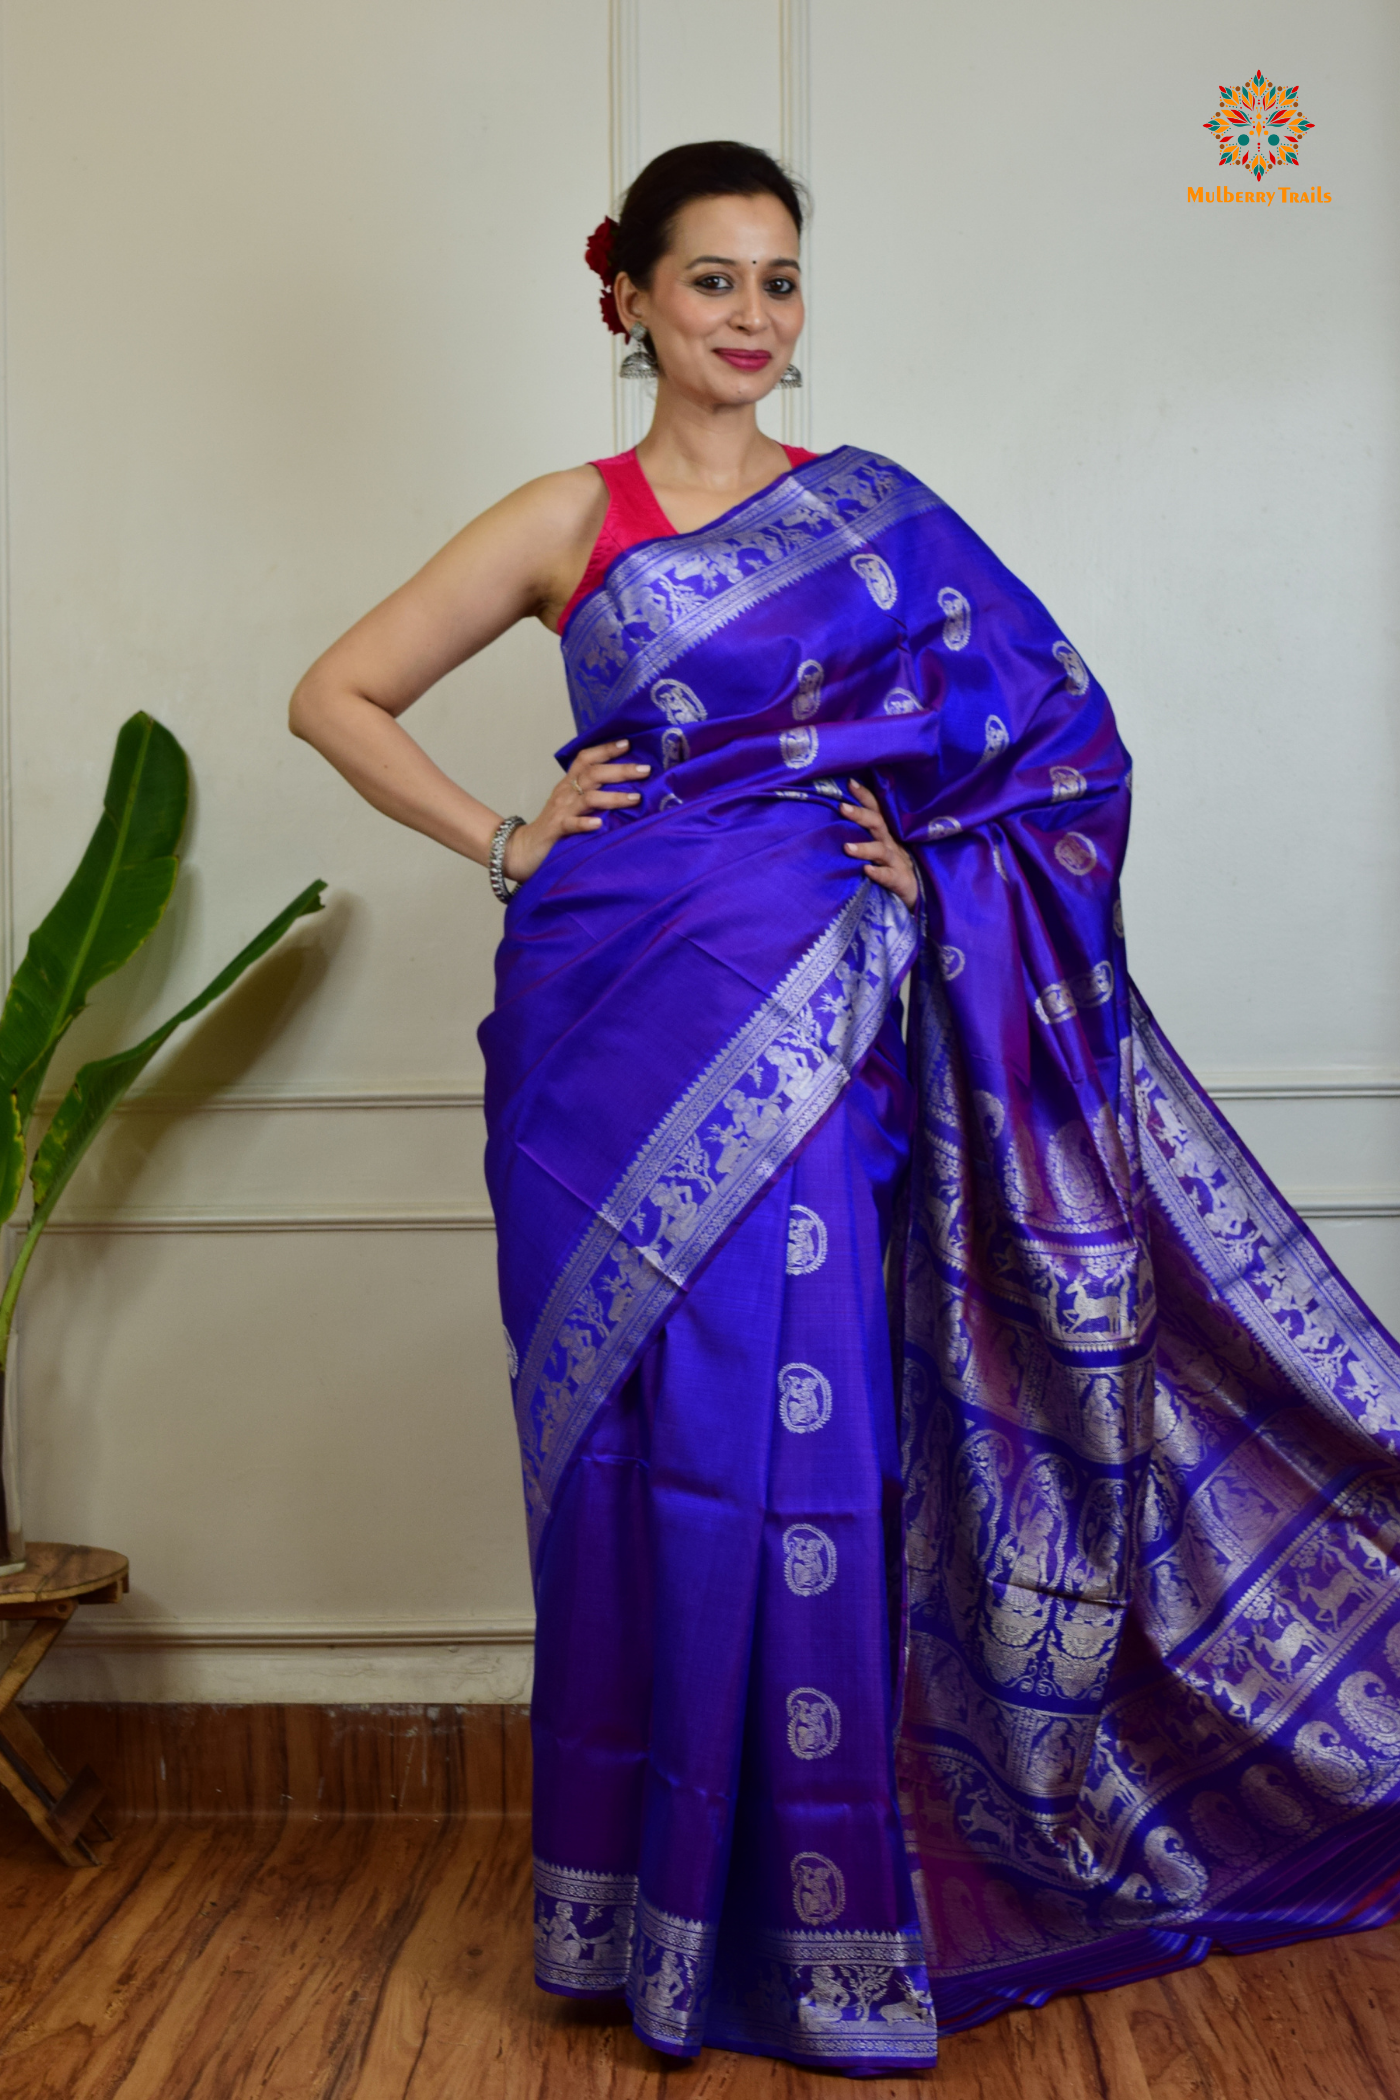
left=290, top=466, right=649, bottom=880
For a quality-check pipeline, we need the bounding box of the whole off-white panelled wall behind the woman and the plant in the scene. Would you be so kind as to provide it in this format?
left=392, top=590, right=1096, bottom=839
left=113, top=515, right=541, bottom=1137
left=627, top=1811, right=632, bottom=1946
left=0, top=0, right=1400, bottom=1699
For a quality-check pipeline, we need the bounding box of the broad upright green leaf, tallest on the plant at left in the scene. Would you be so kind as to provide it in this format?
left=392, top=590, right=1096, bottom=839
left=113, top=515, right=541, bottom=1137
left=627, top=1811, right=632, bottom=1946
left=0, top=714, right=189, bottom=1150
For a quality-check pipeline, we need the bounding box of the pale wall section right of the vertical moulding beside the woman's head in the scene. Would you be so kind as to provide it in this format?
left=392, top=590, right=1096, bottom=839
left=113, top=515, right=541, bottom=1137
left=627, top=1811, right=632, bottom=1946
left=810, top=0, right=1400, bottom=1325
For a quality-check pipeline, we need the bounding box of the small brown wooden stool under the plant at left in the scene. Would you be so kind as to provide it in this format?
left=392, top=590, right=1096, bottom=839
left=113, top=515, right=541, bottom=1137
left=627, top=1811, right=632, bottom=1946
left=0, top=1539, right=128, bottom=1867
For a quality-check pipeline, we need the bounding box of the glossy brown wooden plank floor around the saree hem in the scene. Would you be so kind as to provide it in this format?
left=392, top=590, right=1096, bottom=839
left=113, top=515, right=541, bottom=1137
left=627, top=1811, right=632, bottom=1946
left=0, top=1802, right=1400, bottom=2100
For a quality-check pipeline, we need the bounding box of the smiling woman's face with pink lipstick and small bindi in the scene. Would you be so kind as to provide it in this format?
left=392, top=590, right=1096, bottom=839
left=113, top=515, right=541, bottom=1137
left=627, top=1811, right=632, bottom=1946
left=615, top=191, right=804, bottom=407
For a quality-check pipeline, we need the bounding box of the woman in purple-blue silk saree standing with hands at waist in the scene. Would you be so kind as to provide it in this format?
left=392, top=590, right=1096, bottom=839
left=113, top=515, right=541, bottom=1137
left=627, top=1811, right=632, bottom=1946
left=292, top=143, right=1400, bottom=2073
